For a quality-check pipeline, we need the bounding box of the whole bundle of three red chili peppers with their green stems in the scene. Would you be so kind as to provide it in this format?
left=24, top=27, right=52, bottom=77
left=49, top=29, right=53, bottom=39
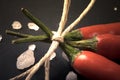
left=6, top=9, right=120, bottom=80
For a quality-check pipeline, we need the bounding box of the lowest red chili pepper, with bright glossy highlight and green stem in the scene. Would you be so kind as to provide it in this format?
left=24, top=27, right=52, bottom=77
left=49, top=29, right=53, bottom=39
left=62, top=44, right=120, bottom=80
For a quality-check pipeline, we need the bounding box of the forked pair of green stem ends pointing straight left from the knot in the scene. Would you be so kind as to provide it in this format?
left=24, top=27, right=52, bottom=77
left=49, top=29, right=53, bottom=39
left=6, top=30, right=51, bottom=44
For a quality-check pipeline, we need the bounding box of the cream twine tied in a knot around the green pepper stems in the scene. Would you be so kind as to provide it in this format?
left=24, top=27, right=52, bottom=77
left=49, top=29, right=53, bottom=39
left=10, top=0, right=95, bottom=80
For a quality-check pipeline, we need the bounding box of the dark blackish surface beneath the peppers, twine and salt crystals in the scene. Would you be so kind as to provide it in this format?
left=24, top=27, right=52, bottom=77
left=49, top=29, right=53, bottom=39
left=0, top=0, right=120, bottom=80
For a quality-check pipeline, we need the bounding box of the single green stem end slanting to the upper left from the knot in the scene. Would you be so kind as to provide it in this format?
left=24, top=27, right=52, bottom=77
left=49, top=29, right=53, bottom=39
left=21, top=8, right=53, bottom=38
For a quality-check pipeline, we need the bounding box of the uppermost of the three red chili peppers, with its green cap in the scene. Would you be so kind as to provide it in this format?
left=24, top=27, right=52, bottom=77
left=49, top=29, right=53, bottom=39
left=65, top=22, right=120, bottom=40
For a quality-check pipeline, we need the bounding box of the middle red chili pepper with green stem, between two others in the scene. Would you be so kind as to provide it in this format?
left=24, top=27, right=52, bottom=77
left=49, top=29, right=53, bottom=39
left=69, top=34, right=120, bottom=60
